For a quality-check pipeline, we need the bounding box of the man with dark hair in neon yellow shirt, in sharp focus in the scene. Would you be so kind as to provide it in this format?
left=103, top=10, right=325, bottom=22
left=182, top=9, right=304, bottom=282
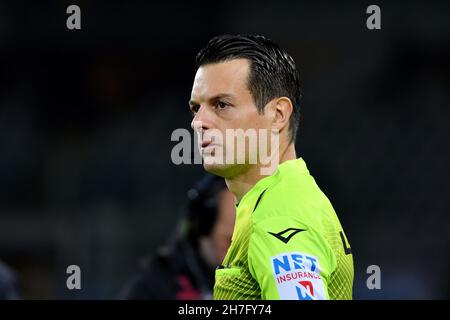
left=189, top=35, right=353, bottom=300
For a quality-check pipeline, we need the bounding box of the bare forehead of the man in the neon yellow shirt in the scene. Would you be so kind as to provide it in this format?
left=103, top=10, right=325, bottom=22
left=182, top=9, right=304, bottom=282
left=192, top=59, right=250, bottom=99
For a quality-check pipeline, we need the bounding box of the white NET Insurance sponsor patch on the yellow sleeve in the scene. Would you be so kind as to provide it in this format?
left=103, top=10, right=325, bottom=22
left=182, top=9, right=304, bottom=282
left=271, top=252, right=326, bottom=300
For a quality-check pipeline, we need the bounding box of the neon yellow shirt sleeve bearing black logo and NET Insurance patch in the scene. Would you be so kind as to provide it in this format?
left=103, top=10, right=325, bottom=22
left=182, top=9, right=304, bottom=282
left=248, top=216, right=336, bottom=300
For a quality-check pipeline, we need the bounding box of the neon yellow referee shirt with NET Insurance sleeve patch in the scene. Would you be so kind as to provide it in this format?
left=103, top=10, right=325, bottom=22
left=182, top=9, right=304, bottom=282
left=214, top=158, right=353, bottom=300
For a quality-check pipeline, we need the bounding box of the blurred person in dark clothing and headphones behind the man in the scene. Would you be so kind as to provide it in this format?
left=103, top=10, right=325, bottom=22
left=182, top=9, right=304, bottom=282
left=120, top=175, right=236, bottom=300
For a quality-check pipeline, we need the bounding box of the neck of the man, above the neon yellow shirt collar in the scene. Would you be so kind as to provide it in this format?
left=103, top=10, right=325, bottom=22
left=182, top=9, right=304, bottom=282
left=225, top=143, right=297, bottom=203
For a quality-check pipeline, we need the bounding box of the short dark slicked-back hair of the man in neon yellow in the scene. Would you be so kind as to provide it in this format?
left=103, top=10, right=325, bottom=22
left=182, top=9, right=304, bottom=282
left=196, top=35, right=301, bottom=141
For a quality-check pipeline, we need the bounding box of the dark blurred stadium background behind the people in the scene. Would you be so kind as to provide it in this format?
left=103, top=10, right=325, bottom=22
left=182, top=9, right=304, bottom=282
left=0, top=0, right=450, bottom=299
